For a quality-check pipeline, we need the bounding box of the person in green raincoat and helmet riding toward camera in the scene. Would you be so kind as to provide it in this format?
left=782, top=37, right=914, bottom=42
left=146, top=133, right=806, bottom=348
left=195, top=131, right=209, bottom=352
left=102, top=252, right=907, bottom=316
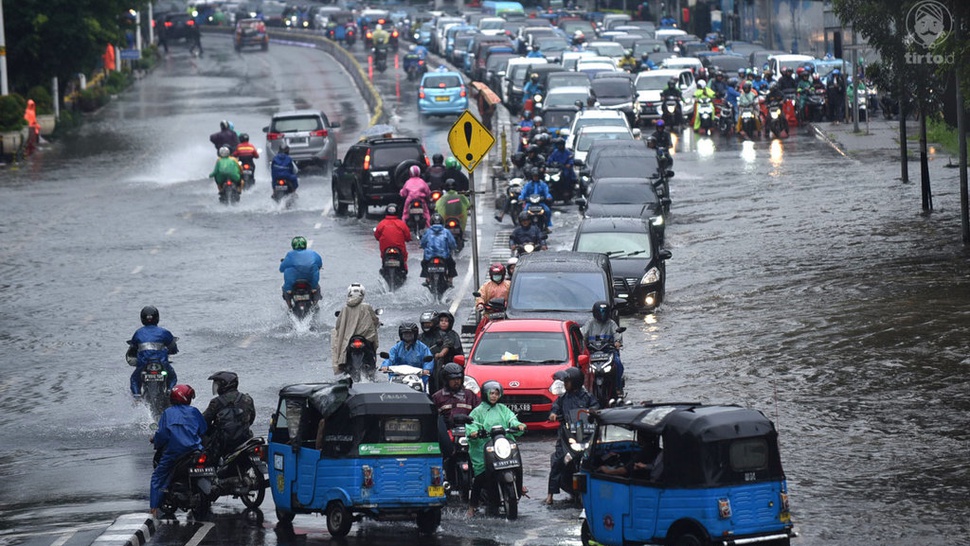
left=465, top=380, right=525, bottom=517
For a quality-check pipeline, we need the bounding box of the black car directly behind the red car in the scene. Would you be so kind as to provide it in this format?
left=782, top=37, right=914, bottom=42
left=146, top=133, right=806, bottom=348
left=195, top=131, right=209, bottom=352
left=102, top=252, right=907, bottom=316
left=505, top=250, right=626, bottom=324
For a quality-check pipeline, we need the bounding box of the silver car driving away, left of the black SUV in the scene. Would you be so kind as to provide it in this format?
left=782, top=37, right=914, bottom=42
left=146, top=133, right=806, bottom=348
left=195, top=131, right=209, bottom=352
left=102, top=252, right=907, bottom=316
left=263, top=110, right=340, bottom=168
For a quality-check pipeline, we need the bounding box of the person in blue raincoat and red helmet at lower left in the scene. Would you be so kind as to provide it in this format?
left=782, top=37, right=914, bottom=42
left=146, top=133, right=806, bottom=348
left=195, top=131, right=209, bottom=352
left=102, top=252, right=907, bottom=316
left=149, top=385, right=207, bottom=518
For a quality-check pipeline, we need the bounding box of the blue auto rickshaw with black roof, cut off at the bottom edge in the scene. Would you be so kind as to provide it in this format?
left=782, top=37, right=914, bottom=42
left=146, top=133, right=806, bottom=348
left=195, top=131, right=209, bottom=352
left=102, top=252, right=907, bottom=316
left=573, top=403, right=796, bottom=546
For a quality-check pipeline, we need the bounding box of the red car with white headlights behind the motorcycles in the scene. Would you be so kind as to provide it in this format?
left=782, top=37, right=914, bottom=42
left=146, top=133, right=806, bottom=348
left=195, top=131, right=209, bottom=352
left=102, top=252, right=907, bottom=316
left=455, top=319, right=589, bottom=430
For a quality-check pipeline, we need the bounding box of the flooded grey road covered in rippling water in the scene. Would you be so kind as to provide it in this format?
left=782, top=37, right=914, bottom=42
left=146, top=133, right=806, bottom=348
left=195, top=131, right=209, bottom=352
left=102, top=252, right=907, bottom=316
left=0, top=31, right=970, bottom=546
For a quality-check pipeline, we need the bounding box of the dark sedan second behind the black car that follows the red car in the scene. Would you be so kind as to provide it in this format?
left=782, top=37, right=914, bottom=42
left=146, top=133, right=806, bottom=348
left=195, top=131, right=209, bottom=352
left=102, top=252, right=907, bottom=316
left=576, top=177, right=666, bottom=242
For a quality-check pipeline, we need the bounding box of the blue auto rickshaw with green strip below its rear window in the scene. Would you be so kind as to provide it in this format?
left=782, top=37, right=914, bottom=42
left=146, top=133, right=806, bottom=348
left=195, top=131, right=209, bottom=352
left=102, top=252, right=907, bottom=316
left=268, top=378, right=446, bottom=537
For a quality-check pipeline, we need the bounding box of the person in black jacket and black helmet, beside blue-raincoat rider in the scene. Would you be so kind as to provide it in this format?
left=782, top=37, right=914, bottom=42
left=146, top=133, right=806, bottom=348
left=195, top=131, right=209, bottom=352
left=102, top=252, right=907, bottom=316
left=202, top=371, right=256, bottom=457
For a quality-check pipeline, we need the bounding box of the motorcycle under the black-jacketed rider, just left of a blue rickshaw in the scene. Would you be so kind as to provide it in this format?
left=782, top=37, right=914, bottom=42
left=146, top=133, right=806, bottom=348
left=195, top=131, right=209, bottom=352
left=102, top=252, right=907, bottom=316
left=209, top=438, right=269, bottom=509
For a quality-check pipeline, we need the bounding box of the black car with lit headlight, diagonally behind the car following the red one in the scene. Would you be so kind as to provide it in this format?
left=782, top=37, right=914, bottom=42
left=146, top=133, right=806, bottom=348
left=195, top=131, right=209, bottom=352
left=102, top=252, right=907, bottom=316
left=573, top=218, right=671, bottom=313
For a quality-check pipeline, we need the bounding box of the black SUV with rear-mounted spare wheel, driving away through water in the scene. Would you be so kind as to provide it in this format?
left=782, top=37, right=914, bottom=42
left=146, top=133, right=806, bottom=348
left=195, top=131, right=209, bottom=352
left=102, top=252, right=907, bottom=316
left=331, top=137, right=428, bottom=218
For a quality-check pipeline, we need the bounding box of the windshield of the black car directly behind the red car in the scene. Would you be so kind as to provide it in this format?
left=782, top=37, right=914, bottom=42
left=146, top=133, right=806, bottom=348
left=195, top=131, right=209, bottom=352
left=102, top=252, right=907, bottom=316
left=509, top=270, right=610, bottom=313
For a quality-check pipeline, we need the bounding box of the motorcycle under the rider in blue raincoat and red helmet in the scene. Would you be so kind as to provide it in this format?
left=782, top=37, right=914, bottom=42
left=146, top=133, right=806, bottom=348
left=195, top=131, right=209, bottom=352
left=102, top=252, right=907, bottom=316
left=154, top=450, right=216, bottom=519
